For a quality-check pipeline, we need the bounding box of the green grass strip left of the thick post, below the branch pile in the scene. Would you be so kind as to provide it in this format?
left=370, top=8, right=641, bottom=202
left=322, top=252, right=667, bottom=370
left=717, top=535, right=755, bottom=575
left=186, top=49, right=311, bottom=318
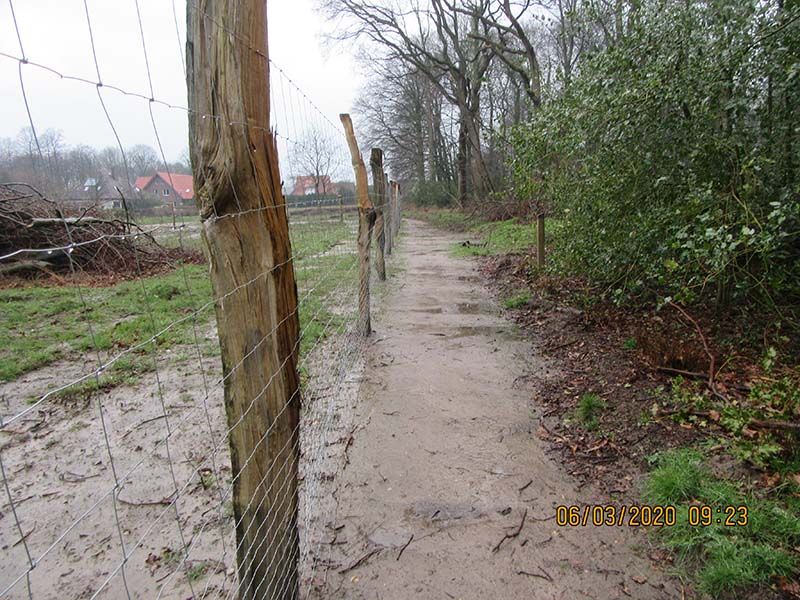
left=0, top=265, right=213, bottom=381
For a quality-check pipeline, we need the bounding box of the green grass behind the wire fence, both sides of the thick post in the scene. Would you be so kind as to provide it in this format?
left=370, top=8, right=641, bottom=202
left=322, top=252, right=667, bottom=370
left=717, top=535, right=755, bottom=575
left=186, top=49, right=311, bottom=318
left=0, top=219, right=358, bottom=399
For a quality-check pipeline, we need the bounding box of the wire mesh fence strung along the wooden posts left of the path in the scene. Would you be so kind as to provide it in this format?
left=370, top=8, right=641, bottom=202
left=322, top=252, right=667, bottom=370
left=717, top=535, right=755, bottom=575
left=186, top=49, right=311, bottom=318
left=0, top=0, right=400, bottom=598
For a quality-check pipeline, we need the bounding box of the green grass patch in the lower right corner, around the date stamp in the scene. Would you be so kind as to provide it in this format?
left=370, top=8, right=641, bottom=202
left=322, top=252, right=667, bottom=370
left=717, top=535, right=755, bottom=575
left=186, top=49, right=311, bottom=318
left=644, top=449, right=800, bottom=598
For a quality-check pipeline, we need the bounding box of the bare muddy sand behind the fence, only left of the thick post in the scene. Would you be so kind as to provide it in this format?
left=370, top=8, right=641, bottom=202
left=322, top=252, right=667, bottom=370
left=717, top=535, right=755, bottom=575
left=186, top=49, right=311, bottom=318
left=0, top=342, right=234, bottom=598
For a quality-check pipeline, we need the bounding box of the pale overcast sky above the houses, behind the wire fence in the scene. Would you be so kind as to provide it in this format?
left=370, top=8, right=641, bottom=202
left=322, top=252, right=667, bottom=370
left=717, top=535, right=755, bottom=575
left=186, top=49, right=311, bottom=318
left=0, top=0, right=360, bottom=160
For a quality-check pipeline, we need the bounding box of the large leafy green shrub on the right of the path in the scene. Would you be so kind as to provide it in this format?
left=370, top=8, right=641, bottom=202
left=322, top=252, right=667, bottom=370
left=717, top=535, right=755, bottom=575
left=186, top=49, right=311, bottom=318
left=511, top=0, right=800, bottom=324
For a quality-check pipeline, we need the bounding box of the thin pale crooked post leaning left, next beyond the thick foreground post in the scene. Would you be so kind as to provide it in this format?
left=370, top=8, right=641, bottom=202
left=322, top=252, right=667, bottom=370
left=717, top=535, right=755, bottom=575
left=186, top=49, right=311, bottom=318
left=339, top=113, right=375, bottom=336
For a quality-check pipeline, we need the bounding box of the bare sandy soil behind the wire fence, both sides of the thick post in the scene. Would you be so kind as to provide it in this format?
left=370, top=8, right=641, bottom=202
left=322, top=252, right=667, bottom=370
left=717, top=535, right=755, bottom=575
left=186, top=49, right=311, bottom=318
left=0, top=328, right=363, bottom=599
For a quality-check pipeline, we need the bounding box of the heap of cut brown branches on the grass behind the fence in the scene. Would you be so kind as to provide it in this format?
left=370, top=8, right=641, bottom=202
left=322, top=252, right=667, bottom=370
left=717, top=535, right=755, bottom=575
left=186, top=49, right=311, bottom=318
left=0, top=184, right=203, bottom=278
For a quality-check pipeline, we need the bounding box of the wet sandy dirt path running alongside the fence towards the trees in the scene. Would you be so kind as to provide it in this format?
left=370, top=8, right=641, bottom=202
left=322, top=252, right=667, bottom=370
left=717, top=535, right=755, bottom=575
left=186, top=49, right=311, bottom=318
left=319, top=221, right=681, bottom=600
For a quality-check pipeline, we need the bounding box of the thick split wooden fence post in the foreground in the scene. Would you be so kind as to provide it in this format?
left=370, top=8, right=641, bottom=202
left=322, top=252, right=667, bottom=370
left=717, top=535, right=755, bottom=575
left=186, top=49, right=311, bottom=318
left=186, top=0, right=300, bottom=600
